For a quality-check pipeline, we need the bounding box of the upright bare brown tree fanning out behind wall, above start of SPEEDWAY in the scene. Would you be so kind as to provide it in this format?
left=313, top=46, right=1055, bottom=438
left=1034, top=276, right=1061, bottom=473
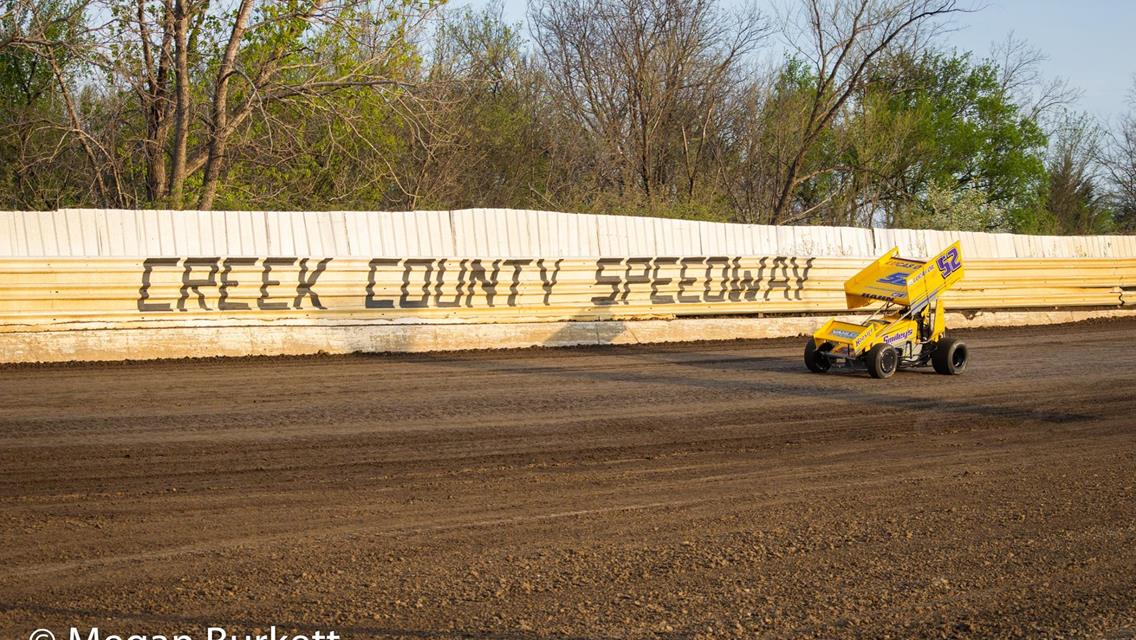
left=529, top=0, right=767, bottom=210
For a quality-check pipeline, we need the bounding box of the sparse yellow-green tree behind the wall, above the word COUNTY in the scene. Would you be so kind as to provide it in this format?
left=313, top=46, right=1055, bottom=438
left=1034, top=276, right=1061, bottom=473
left=398, top=5, right=551, bottom=208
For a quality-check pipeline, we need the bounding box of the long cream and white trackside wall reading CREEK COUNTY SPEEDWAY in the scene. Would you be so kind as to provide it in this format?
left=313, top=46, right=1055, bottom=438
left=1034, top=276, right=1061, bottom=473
left=0, top=210, right=1136, bottom=361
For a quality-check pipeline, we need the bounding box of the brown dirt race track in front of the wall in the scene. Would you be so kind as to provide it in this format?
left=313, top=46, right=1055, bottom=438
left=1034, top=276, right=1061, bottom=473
left=0, top=321, right=1136, bottom=640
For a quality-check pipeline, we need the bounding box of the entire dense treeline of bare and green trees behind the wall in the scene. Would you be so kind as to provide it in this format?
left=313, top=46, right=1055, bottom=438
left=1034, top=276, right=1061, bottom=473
left=0, top=0, right=1136, bottom=233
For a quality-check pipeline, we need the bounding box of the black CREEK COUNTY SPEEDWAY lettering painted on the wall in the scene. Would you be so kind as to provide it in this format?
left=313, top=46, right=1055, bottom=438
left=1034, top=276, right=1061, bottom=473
left=136, top=251, right=815, bottom=313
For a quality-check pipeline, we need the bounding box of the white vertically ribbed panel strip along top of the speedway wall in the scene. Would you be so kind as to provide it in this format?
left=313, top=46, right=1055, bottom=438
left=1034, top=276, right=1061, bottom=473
left=0, top=209, right=1136, bottom=258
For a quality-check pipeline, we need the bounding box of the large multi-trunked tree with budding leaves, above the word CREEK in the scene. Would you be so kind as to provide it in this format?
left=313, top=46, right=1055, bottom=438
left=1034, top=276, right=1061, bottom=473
left=5, top=0, right=436, bottom=209
